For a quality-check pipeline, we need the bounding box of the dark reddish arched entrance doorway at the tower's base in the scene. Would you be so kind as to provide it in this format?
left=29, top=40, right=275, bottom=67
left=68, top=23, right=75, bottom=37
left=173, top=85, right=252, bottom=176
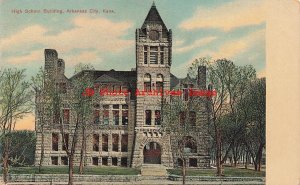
left=143, top=142, right=161, bottom=164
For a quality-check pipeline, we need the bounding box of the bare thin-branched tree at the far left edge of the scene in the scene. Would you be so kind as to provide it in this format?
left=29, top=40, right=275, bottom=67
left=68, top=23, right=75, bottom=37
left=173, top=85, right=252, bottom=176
left=0, top=68, right=32, bottom=182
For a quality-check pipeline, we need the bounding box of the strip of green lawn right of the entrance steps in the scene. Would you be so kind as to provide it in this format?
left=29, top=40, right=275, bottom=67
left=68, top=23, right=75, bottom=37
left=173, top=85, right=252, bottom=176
left=168, top=167, right=265, bottom=177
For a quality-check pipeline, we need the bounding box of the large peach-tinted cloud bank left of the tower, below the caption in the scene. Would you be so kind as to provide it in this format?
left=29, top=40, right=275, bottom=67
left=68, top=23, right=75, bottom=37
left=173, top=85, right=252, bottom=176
left=0, top=16, right=134, bottom=64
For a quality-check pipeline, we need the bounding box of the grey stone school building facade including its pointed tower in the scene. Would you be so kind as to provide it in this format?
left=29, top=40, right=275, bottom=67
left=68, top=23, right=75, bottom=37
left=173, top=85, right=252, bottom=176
left=35, top=5, right=210, bottom=167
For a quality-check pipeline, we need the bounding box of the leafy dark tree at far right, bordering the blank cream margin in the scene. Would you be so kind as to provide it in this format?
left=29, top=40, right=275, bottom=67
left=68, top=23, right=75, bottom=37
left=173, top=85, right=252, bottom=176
left=239, top=78, right=266, bottom=171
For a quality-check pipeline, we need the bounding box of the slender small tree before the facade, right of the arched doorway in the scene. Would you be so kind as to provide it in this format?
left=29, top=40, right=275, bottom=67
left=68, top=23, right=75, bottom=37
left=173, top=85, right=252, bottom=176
left=162, top=96, right=206, bottom=185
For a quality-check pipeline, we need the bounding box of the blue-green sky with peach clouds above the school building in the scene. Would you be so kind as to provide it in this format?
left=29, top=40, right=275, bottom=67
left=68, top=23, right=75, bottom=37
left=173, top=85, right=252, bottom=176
left=0, top=0, right=265, bottom=77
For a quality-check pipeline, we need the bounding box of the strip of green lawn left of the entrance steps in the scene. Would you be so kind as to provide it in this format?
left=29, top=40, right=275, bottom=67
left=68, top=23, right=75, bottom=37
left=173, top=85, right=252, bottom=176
left=5, top=166, right=140, bottom=175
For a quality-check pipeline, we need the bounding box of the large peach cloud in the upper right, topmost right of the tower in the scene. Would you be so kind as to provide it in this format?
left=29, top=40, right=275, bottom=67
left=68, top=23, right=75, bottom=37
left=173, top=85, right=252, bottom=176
left=179, top=0, right=266, bottom=31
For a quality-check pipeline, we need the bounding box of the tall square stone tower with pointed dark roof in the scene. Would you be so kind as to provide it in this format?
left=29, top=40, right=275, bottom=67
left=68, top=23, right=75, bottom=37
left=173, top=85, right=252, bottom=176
left=132, top=3, right=173, bottom=167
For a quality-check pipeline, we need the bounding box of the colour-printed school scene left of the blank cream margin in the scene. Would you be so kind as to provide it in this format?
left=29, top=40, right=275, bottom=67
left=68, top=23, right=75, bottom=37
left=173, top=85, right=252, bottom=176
left=0, top=0, right=299, bottom=184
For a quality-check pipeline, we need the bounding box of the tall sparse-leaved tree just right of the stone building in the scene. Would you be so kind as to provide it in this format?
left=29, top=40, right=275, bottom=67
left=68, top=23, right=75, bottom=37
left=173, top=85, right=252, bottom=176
left=189, top=58, right=255, bottom=176
